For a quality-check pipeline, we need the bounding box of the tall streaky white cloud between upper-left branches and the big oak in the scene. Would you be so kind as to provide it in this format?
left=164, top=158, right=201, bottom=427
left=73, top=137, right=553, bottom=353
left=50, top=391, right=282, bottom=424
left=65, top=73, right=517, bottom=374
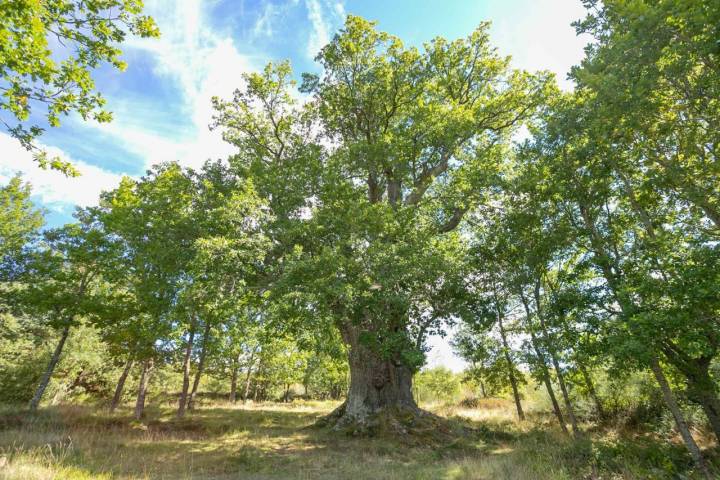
left=83, top=0, right=262, bottom=172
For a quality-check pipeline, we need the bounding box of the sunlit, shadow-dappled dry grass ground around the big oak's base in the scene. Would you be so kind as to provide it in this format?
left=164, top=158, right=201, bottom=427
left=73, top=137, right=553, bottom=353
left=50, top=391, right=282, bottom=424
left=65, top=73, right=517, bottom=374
left=0, top=400, right=710, bottom=480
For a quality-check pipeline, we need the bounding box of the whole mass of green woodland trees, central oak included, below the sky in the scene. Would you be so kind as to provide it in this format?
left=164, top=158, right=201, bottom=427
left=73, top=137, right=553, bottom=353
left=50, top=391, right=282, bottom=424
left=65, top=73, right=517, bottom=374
left=0, top=0, right=720, bottom=478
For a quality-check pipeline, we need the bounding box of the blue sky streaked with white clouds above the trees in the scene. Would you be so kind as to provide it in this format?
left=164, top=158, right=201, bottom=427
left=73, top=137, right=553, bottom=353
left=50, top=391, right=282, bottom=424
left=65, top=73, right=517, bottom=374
left=0, top=0, right=587, bottom=368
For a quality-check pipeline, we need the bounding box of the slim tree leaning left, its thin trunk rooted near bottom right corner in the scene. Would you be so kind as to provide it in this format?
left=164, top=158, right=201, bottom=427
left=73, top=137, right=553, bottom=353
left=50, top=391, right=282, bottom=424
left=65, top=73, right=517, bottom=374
left=524, top=90, right=718, bottom=472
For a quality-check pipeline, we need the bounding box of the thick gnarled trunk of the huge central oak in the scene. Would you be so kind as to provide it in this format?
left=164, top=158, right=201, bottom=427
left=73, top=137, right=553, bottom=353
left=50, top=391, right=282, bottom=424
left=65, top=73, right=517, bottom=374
left=330, top=326, right=420, bottom=427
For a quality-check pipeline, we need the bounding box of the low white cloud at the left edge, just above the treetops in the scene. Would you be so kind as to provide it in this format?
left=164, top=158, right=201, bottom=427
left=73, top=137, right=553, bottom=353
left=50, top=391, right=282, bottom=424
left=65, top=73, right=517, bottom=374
left=0, top=132, right=122, bottom=211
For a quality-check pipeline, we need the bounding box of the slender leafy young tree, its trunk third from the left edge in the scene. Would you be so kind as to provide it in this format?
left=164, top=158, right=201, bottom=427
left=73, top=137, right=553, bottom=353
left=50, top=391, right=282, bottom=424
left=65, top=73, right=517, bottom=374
left=95, top=163, right=198, bottom=419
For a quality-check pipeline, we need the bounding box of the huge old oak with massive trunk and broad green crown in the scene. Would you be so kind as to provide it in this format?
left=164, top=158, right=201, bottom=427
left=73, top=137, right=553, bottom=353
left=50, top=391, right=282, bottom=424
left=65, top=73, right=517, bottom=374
left=215, top=16, right=549, bottom=425
